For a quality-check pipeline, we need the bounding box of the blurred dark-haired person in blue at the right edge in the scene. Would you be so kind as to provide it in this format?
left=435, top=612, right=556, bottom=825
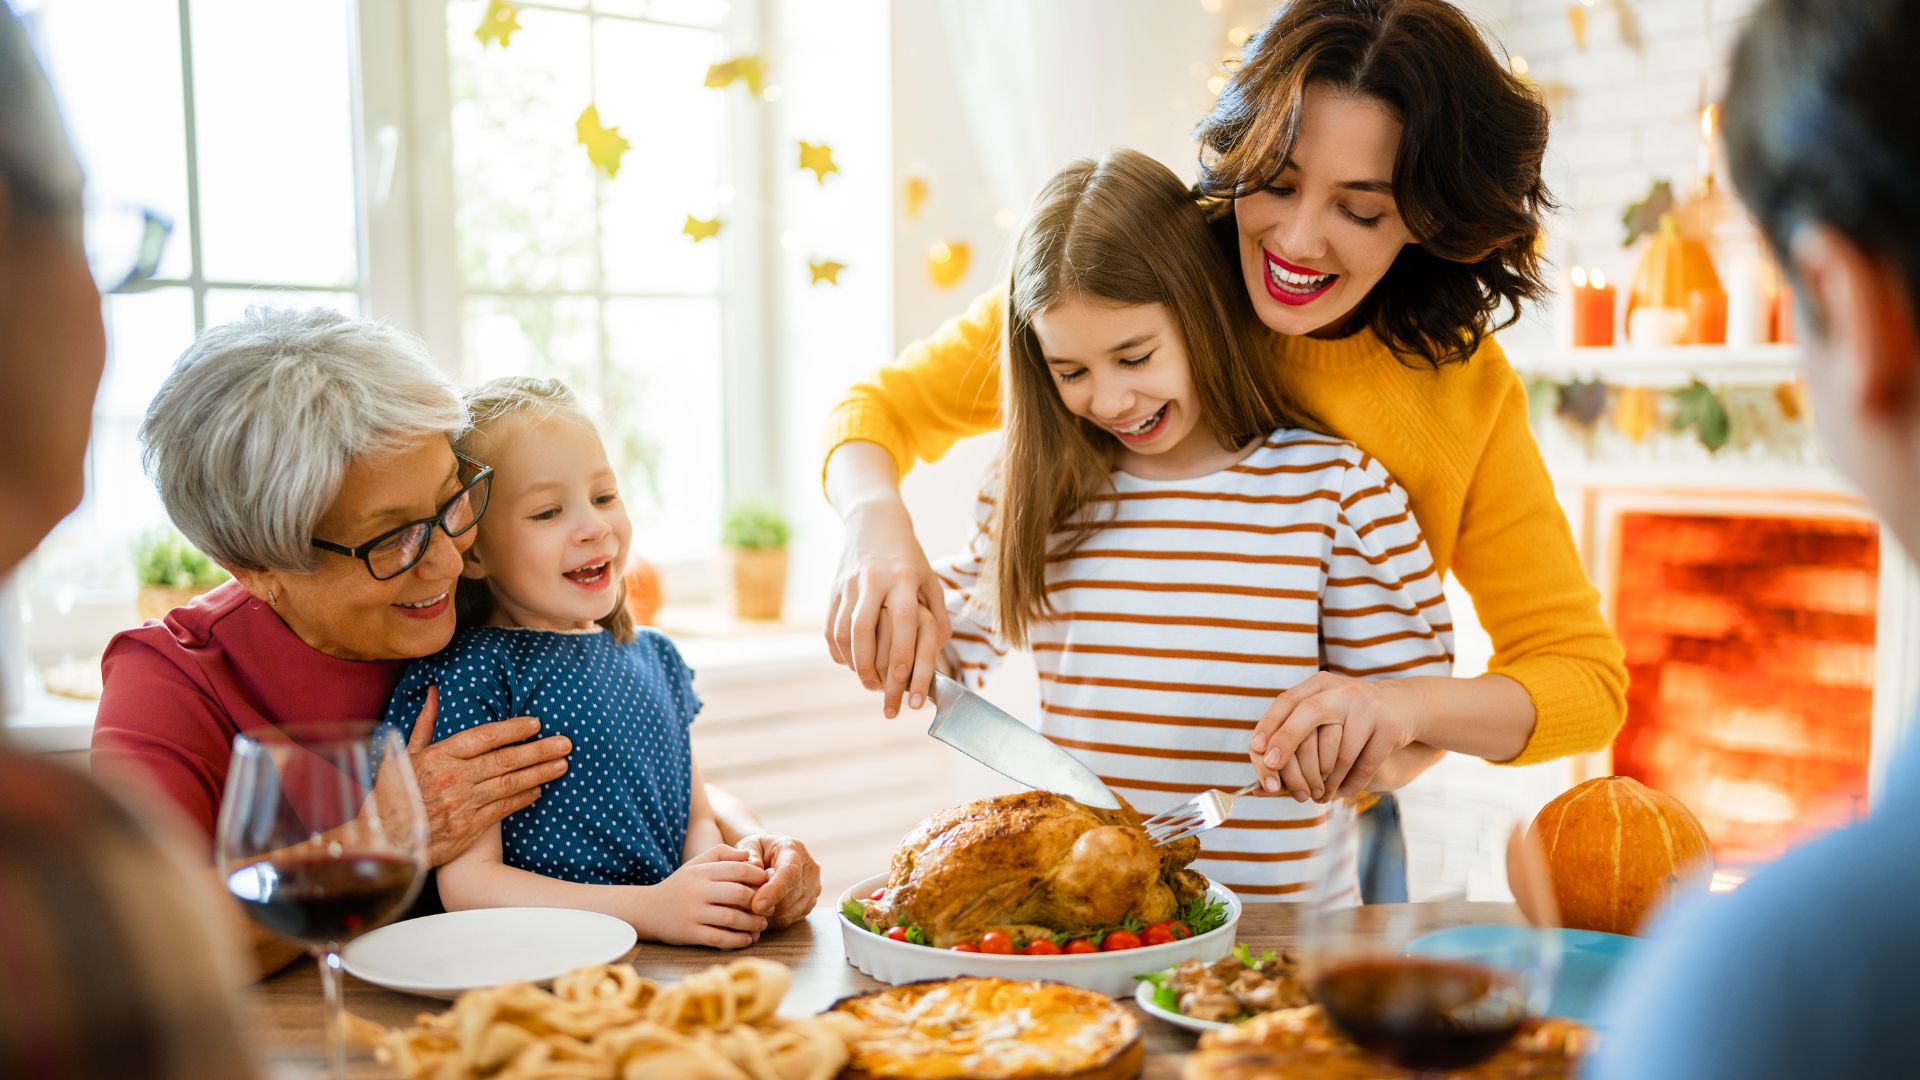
left=1592, top=0, right=1920, bottom=1080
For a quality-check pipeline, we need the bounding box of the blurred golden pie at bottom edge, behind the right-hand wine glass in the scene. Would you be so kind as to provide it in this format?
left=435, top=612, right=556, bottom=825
left=1181, top=1005, right=1594, bottom=1080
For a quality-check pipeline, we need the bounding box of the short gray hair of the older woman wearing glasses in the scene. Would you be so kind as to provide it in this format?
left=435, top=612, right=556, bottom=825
left=140, top=307, right=467, bottom=571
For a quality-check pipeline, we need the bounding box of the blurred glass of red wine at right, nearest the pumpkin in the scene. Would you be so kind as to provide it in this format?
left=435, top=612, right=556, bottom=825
left=1296, top=807, right=1559, bottom=1074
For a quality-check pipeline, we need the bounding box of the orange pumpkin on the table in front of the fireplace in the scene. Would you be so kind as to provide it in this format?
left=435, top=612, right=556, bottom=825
left=1530, top=776, right=1713, bottom=934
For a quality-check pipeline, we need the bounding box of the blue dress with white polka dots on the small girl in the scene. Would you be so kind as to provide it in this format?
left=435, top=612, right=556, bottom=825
left=386, top=626, right=701, bottom=886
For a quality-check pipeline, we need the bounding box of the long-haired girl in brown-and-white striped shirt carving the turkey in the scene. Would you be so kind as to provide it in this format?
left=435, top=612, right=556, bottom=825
left=921, top=150, right=1452, bottom=899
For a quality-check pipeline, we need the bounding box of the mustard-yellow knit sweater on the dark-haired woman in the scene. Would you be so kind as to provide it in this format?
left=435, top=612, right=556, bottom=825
left=828, top=292, right=1626, bottom=765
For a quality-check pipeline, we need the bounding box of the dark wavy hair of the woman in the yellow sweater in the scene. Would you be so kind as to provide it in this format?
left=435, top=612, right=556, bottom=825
left=1194, top=0, right=1555, bottom=367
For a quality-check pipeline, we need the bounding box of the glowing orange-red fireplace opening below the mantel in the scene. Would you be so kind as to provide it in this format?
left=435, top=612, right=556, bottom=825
left=1611, top=503, right=1882, bottom=864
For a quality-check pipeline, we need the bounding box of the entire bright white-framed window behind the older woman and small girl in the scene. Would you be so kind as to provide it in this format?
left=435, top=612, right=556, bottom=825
left=13, top=0, right=762, bottom=661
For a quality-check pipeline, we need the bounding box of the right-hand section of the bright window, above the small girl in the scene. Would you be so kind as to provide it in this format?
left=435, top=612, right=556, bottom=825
left=422, top=0, right=753, bottom=561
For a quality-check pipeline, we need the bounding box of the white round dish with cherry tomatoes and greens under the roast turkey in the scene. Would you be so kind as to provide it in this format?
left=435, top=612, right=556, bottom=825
left=839, top=874, right=1240, bottom=997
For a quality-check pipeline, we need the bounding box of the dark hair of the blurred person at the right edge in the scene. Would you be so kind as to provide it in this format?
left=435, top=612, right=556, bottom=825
left=1722, top=0, right=1920, bottom=328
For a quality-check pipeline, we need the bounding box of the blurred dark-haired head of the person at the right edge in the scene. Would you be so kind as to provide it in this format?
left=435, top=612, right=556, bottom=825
left=1724, top=0, right=1920, bottom=553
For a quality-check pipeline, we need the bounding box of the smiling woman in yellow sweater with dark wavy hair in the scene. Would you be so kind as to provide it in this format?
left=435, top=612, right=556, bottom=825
left=826, top=0, right=1626, bottom=799
